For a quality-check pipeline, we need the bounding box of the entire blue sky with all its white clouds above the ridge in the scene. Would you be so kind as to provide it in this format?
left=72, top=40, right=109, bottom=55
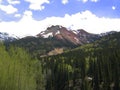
left=0, top=0, right=120, bottom=36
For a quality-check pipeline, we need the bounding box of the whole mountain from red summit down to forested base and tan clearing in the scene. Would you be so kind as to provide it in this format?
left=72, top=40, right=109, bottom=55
left=6, top=25, right=118, bottom=57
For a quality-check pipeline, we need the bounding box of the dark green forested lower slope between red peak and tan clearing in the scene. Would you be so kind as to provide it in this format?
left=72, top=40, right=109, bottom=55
left=6, top=36, right=77, bottom=57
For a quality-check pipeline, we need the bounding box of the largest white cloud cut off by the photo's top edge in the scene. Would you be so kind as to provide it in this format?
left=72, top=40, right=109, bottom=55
left=25, top=0, right=50, bottom=10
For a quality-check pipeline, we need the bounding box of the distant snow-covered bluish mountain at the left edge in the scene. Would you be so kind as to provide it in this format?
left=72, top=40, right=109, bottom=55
left=0, top=32, right=18, bottom=42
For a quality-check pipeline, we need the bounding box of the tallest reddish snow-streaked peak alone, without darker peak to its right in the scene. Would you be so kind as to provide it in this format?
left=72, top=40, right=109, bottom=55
left=37, top=25, right=82, bottom=45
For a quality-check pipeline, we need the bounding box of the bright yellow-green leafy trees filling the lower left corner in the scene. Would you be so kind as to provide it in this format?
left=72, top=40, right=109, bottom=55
left=0, top=44, right=45, bottom=90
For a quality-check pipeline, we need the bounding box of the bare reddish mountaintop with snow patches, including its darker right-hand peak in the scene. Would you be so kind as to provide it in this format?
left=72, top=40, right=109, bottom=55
left=37, top=25, right=100, bottom=45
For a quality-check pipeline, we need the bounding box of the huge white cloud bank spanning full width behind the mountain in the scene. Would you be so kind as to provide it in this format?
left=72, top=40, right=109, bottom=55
left=0, top=11, right=120, bottom=36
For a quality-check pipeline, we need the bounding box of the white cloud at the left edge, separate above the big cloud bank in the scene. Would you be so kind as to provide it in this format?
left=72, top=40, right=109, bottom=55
left=0, top=5, right=18, bottom=14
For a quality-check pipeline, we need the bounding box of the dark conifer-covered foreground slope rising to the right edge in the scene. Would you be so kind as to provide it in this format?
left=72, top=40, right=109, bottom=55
left=41, top=33, right=120, bottom=90
